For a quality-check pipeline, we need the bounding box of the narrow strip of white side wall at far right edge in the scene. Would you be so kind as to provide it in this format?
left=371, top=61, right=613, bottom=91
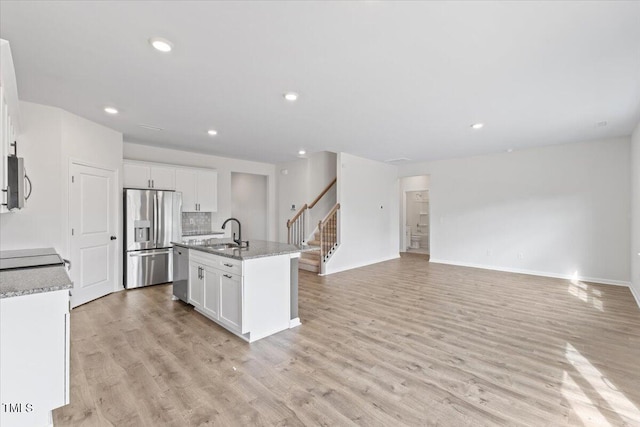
left=631, top=123, right=640, bottom=306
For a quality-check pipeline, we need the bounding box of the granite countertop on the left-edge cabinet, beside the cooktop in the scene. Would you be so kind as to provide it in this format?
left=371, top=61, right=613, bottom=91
left=0, top=266, right=73, bottom=298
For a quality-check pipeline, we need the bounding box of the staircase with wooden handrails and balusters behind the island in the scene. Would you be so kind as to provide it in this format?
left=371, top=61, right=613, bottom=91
left=287, top=179, right=340, bottom=274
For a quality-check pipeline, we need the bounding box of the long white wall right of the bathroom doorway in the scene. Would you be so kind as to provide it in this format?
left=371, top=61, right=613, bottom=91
left=400, top=138, right=631, bottom=284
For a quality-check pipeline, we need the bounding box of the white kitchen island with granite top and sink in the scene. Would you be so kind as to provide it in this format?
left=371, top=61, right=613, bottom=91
left=173, top=239, right=308, bottom=342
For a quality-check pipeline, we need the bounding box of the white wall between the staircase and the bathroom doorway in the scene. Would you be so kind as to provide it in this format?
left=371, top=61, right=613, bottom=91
left=326, top=153, right=399, bottom=274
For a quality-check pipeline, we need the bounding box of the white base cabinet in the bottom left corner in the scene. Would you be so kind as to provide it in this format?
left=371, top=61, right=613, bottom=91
left=0, top=290, right=70, bottom=427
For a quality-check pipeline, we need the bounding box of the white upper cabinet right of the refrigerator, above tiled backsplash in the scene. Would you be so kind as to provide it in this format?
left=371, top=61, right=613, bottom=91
left=176, top=168, right=218, bottom=212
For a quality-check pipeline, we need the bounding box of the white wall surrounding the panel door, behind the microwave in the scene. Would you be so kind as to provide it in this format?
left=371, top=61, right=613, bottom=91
left=0, top=102, right=122, bottom=289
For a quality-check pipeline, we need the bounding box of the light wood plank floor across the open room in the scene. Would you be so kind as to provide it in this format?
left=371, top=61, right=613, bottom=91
left=54, top=254, right=640, bottom=427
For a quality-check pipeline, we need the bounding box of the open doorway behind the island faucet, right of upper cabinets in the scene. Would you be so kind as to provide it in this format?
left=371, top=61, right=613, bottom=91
left=231, top=172, right=268, bottom=241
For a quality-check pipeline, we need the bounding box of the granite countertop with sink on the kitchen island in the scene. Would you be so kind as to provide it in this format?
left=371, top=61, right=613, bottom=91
left=172, top=238, right=318, bottom=260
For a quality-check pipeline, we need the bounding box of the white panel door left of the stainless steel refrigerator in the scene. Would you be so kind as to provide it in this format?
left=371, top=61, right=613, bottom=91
left=69, top=163, right=119, bottom=307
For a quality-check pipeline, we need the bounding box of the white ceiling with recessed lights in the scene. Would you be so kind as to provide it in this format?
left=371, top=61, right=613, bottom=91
left=0, top=0, right=640, bottom=163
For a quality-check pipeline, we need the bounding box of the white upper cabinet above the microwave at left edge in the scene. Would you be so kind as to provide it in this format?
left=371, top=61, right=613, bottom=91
left=0, top=39, right=19, bottom=213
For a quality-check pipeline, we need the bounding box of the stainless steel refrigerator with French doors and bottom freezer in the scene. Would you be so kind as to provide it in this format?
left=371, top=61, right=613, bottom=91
left=123, top=189, right=182, bottom=289
